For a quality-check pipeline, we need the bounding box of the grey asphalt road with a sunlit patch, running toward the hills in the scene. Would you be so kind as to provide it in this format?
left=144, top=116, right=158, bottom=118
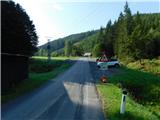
left=1, top=58, right=104, bottom=120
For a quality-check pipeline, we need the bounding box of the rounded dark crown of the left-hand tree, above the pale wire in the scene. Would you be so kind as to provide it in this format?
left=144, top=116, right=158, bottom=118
left=1, top=1, right=38, bottom=56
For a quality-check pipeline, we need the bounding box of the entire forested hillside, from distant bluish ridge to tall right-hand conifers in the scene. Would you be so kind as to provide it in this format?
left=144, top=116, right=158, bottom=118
left=39, top=3, right=160, bottom=60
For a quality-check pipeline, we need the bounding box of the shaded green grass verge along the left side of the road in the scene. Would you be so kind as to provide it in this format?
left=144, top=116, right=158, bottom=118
left=1, top=57, right=71, bottom=103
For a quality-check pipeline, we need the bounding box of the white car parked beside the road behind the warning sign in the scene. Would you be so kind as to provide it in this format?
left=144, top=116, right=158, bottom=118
left=96, top=59, right=120, bottom=68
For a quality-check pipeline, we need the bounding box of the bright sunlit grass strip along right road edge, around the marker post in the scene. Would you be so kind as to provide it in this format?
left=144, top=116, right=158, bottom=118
left=97, top=83, right=159, bottom=120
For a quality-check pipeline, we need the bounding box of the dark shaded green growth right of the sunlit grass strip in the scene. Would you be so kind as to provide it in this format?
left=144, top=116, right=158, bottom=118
left=109, top=67, right=160, bottom=117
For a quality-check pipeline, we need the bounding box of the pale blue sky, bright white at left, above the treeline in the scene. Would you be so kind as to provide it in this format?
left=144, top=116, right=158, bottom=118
left=13, top=0, right=160, bottom=45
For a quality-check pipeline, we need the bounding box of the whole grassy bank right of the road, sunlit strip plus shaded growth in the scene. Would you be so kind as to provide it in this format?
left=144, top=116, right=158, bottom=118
left=97, top=67, right=160, bottom=120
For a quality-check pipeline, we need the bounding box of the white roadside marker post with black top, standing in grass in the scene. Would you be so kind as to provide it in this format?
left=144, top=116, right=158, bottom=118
left=120, top=90, right=127, bottom=114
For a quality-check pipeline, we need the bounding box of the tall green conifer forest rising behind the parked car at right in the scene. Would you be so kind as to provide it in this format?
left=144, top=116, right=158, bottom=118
left=93, top=3, right=160, bottom=59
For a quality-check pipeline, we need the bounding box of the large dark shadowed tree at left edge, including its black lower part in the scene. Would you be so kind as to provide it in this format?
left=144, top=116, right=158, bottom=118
left=1, top=0, right=38, bottom=91
